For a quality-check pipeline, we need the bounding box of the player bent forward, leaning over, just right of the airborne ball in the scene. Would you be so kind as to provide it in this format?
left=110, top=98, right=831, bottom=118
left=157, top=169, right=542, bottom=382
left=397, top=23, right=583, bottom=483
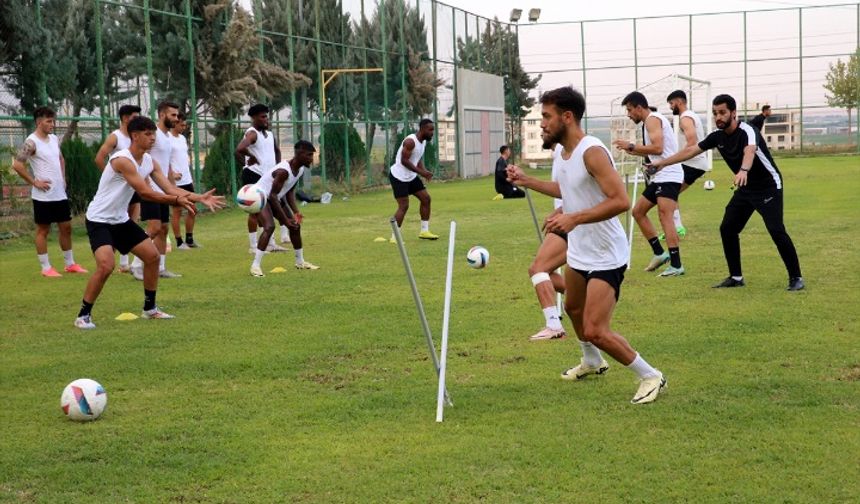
left=251, top=140, right=319, bottom=277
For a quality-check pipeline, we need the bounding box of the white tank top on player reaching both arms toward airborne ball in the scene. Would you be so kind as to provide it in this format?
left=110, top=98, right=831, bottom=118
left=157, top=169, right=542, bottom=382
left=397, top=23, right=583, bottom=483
left=87, top=150, right=153, bottom=224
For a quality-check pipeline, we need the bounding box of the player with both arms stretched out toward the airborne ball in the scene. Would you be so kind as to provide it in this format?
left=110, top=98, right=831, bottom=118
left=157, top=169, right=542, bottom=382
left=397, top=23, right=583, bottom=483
left=75, top=117, right=224, bottom=329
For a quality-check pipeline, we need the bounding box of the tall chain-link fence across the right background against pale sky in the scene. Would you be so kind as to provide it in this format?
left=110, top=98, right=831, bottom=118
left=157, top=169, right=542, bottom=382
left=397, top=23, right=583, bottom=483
left=518, top=3, right=860, bottom=159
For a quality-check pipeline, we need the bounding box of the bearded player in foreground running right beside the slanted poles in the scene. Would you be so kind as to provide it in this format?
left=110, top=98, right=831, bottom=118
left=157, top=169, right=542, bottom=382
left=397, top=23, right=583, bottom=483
left=508, top=86, right=666, bottom=404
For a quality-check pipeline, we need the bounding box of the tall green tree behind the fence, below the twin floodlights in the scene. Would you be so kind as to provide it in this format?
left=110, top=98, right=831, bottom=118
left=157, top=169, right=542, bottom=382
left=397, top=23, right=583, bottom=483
left=457, top=18, right=541, bottom=151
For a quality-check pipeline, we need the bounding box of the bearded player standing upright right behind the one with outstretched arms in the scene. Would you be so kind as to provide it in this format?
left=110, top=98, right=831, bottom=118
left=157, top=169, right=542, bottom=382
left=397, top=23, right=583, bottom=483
left=131, top=101, right=182, bottom=280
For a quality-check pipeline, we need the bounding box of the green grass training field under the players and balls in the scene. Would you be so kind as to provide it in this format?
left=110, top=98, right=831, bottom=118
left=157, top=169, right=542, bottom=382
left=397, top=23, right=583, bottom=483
left=0, top=157, right=860, bottom=503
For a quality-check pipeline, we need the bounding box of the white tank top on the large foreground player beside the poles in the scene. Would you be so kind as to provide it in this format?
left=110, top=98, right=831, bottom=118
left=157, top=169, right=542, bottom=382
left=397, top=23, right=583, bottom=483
left=553, top=136, right=629, bottom=271
